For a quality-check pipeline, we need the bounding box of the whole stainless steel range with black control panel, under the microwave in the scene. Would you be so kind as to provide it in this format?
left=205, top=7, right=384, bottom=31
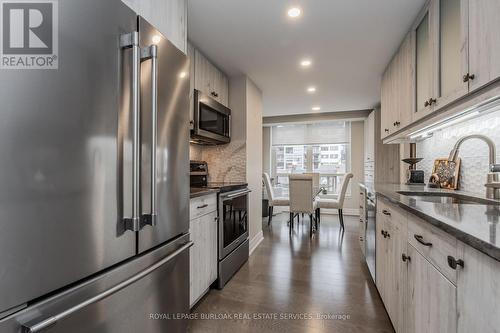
left=190, top=161, right=251, bottom=289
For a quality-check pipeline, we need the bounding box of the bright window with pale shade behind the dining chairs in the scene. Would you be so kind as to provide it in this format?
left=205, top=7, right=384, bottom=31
left=271, top=121, right=351, bottom=195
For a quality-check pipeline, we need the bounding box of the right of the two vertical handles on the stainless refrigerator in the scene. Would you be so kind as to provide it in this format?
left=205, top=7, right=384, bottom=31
left=140, top=45, right=158, bottom=229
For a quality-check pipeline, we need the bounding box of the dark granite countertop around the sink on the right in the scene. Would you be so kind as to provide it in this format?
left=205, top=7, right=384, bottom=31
left=360, top=183, right=500, bottom=261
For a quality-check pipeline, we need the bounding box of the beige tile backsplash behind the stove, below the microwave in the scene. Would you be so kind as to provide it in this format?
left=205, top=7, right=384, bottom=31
left=189, top=141, right=246, bottom=182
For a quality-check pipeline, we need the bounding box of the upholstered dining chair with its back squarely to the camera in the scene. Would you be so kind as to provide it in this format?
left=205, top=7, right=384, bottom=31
left=288, top=174, right=317, bottom=237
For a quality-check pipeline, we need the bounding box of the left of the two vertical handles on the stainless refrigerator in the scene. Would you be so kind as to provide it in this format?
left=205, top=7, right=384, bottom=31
left=120, top=31, right=141, bottom=231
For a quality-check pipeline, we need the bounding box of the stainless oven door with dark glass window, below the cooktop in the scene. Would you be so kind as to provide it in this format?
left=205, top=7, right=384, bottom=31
left=219, top=189, right=250, bottom=260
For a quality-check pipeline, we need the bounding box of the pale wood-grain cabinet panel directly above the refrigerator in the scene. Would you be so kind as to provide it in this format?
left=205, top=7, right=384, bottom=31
left=122, top=0, right=187, bottom=53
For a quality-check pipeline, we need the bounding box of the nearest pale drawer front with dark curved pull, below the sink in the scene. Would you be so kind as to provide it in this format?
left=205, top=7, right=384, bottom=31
left=408, top=215, right=457, bottom=284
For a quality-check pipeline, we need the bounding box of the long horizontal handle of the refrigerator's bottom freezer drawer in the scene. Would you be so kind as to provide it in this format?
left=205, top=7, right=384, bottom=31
left=22, top=241, right=194, bottom=333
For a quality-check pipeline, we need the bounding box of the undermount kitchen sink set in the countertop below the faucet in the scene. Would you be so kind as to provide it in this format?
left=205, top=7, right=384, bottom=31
left=397, top=191, right=500, bottom=205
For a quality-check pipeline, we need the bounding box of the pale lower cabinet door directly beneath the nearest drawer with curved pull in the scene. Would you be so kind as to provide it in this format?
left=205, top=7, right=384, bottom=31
left=405, top=245, right=458, bottom=333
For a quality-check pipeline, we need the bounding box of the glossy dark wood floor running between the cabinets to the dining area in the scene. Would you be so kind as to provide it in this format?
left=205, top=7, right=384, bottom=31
left=190, top=213, right=393, bottom=333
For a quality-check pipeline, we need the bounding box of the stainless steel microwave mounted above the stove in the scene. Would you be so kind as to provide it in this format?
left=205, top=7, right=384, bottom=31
left=191, top=89, right=231, bottom=145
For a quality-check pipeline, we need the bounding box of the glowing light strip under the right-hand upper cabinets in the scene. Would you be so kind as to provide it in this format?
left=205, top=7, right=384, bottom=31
left=409, top=96, right=500, bottom=140
